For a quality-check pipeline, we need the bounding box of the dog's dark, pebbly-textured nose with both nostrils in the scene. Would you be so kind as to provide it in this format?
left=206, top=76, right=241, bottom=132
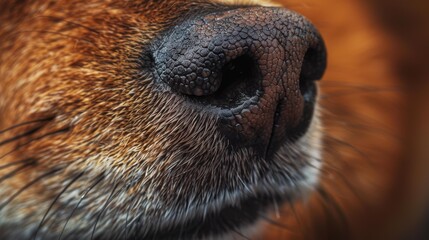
left=154, top=7, right=326, bottom=158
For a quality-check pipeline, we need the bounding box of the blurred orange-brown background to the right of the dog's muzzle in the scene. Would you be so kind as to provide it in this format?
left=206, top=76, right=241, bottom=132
left=261, top=0, right=429, bottom=239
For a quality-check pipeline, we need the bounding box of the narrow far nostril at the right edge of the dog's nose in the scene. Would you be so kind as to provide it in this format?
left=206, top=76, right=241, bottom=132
left=299, top=46, right=326, bottom=100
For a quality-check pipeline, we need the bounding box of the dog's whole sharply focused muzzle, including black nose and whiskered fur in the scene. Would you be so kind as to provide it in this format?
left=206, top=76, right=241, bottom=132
left=0, top=0, right=326, bottom=239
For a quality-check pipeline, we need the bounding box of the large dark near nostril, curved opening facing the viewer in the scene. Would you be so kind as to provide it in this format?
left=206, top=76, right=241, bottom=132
left=193, top=55, right=262, bottom=108
